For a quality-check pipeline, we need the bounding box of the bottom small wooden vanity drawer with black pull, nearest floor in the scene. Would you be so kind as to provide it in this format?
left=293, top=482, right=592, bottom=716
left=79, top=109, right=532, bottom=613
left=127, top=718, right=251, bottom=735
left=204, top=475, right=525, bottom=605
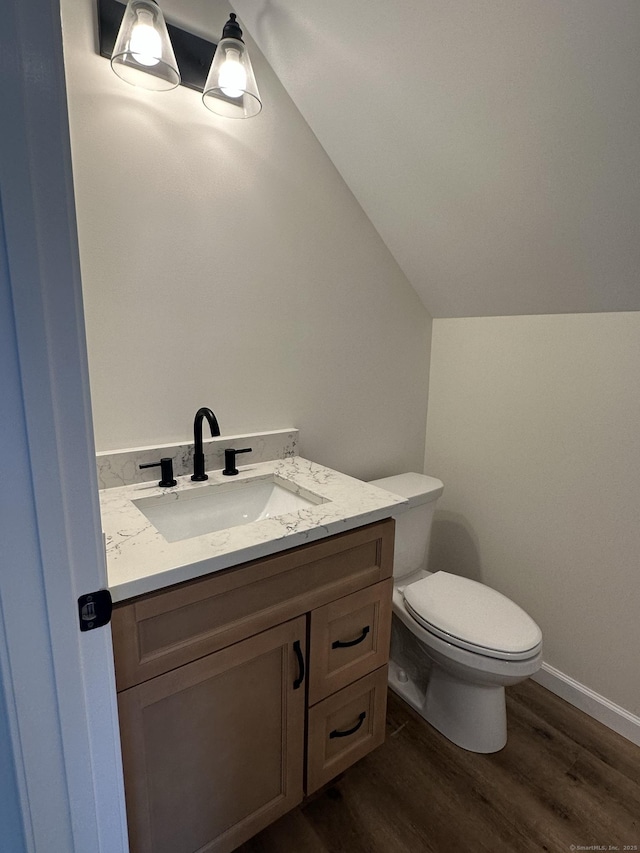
left=306, top=666, right=388, bottom=794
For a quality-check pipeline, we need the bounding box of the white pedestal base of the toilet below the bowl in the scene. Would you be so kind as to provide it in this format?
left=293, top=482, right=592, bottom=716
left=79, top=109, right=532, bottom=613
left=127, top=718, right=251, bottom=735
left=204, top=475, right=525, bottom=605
left=389, top=660, right=507, bottom=753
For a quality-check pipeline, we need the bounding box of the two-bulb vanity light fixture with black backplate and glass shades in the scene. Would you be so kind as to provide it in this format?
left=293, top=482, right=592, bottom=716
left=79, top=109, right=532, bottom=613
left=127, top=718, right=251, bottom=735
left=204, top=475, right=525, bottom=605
left=98, top=0, right=262, bottom=118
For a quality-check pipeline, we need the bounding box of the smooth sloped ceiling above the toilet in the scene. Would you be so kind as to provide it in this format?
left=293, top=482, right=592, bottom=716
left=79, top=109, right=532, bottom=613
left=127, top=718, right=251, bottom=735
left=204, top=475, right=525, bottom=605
left=234, top=0, right=640, bottom=317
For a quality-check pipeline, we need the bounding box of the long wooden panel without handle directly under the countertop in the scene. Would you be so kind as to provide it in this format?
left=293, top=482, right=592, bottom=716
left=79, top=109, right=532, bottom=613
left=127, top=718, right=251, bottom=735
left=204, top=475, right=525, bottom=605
left=112, top=519, right=394, bottom=691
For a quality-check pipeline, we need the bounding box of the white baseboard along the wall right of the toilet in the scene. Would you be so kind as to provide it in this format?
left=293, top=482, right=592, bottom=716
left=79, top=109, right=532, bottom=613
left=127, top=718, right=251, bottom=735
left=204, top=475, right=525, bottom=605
left=532, top=663, right=640, bottom=746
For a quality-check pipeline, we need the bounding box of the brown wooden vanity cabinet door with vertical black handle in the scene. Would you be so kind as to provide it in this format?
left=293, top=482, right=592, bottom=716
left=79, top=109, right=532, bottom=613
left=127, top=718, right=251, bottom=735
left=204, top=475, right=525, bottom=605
left=118, top=617, right=306, bottom=853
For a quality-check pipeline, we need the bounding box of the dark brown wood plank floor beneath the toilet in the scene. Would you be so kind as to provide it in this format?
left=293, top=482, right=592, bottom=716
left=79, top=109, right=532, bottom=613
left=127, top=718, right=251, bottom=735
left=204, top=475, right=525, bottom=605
left=238, top=681, right=640, bottom=853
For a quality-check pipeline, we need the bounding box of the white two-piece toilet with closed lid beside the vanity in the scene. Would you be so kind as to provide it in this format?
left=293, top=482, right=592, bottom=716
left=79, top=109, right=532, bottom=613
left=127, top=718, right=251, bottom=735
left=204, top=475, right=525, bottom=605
left=372, top=474, right=542, bottom=752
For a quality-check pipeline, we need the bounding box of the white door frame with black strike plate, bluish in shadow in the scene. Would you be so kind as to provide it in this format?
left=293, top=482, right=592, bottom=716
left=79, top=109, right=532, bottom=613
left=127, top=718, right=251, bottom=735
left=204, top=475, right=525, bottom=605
left=0, top=0, right=128, bottom=853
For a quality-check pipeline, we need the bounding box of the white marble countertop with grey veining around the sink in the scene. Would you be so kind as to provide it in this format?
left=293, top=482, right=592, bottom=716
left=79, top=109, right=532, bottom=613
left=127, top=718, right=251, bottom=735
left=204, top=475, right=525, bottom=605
left=100, top=456, right=406, bottom=602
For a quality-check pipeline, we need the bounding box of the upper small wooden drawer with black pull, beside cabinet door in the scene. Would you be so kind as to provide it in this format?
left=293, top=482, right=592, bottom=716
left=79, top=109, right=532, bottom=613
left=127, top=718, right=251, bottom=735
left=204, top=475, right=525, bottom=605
left=309, top=578, right=393, bottom=705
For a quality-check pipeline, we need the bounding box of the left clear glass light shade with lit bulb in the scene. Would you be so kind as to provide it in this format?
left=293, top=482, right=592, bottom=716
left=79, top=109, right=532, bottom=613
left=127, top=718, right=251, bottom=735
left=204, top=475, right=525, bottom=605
left=111, top=0, right=180, bottom=92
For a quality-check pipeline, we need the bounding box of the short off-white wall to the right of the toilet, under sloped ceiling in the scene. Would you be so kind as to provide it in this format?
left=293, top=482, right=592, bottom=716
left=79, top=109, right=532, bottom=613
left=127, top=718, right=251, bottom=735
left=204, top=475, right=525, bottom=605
left=425, top=312, right=640, bottom=715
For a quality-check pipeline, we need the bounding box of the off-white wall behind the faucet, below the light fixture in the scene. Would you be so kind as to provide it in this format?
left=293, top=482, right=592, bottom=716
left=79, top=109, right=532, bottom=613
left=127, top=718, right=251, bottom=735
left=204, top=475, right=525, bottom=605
left=62, top=0, right=431, bottom=477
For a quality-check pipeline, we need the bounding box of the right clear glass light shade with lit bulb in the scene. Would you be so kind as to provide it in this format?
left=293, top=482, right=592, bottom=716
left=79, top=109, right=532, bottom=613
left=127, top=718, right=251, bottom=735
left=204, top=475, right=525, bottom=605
left=202, top=38, right=262, bottom=118
